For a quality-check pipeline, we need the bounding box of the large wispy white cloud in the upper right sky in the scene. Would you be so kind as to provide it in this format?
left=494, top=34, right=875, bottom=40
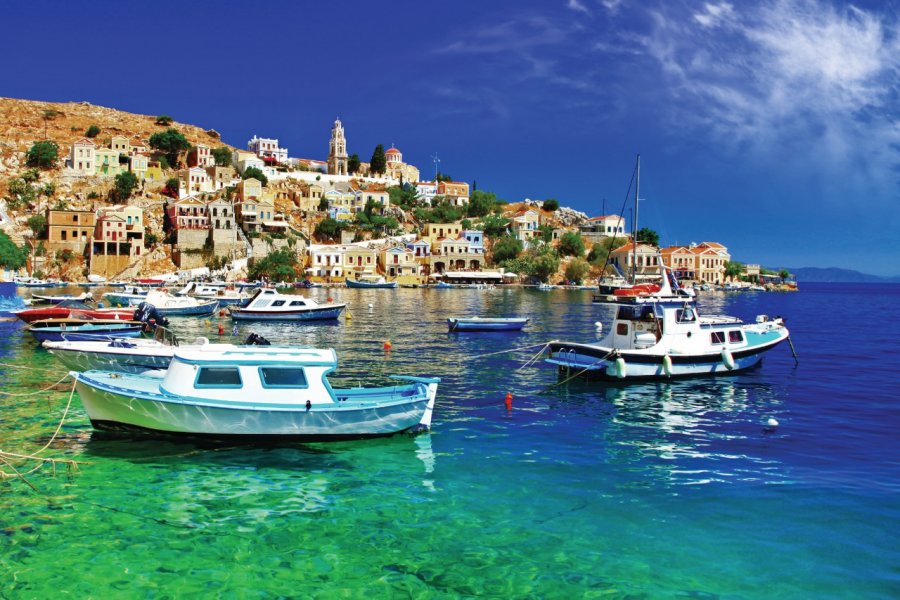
left=639, top=0, right=900, bottom=184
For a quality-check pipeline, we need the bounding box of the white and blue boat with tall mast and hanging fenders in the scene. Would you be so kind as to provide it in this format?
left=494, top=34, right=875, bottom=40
left=546, top=268, right=790, bottom=380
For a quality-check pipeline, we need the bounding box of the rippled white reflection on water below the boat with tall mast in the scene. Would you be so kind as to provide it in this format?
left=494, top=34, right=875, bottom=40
left=548, top=378, right=788, bottom=487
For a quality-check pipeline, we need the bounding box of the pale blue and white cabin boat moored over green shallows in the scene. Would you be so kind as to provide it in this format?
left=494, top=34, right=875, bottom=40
left=72, top=346, right=440, bottom=440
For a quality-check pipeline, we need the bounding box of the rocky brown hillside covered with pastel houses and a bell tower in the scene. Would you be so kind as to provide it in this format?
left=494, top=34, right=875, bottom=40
left=0, top=98, right=761, bottom=285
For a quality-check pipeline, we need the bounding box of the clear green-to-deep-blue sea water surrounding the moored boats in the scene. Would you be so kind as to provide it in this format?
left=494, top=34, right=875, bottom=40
left=0, top=284, right=900, bottom=598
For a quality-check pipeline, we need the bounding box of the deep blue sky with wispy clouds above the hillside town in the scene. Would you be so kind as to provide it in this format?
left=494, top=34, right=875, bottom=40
left=0, top=0, right=900, bottom=275
